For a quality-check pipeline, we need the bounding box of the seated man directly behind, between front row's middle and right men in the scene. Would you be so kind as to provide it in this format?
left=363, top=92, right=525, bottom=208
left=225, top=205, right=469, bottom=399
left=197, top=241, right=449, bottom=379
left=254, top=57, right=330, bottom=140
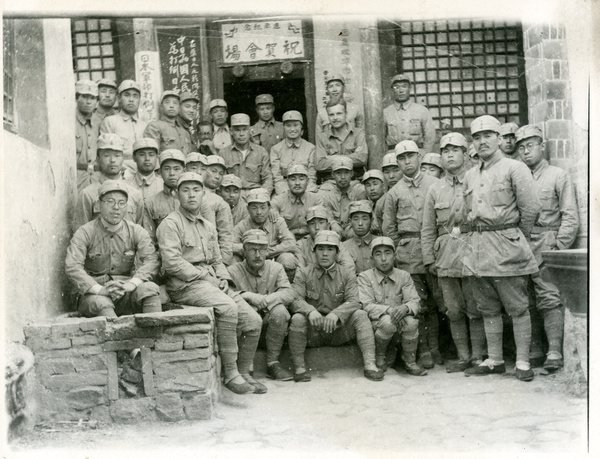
left=342, top=200, right=373, bottom=274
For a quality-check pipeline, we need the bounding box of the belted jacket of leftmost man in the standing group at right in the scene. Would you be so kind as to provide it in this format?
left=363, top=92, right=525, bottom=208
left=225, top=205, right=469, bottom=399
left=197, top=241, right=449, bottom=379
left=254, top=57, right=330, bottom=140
left=381, top=172, right=439, bottom=274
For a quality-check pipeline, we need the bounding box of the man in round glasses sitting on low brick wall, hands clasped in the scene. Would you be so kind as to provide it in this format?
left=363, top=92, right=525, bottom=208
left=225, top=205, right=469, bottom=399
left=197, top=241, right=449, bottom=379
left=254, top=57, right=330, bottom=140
left=65, top=180, right=161, bottom=317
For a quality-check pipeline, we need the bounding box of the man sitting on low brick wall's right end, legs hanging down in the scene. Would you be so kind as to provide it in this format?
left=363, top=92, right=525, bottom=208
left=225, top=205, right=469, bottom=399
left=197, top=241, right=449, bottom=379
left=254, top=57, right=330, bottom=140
left=156, top=172, right=267, bottom=394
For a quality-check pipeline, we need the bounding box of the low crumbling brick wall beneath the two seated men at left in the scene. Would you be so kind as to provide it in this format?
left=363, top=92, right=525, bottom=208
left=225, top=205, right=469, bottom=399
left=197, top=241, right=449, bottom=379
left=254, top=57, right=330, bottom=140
left=24, top=308, right=220, bottom=423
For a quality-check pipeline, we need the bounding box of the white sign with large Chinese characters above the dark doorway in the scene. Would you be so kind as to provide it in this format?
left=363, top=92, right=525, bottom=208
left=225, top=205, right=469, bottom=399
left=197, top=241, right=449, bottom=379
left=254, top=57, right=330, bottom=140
left=221, top=19, right=304, bottom=64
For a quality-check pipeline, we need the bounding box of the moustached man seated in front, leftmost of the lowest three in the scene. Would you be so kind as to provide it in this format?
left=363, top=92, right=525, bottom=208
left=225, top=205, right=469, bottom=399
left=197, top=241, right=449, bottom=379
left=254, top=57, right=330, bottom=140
left=227, top=229, right=294, bottom=381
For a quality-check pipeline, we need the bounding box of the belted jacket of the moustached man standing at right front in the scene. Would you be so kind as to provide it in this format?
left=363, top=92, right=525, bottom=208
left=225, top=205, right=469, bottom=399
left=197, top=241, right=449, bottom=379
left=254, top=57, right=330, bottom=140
left=463, top=150, right=541, bottom=277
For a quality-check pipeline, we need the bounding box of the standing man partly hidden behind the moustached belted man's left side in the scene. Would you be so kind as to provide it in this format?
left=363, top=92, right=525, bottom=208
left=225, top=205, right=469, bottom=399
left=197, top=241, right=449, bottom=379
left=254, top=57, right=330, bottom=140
left=421, top=132, right=485, bottom=373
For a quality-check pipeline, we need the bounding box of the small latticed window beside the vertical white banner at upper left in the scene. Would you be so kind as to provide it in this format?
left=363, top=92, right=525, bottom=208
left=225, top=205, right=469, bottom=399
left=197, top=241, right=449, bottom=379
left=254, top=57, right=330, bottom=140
left=71, top=19, right=118, bottom=81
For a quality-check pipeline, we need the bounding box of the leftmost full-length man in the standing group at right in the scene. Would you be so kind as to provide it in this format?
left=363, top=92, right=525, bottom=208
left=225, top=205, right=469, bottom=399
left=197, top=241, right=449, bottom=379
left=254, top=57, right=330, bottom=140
left=382, top=140, right=443, bottom=368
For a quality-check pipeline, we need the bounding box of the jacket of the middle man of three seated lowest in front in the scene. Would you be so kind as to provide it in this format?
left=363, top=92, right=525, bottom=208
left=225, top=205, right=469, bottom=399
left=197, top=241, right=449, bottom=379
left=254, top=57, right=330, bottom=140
left=290, top=263, right=360, bottom=324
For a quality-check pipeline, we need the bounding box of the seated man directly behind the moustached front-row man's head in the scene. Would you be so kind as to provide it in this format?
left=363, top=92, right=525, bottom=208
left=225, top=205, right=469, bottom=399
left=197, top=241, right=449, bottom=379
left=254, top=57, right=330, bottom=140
left=233, top=188, right=298, bottom=277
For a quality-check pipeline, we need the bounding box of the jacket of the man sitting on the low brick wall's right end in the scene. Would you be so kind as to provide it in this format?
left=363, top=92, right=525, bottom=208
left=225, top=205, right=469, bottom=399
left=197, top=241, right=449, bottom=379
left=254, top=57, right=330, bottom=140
left=156, top=208, right=231, bottom=292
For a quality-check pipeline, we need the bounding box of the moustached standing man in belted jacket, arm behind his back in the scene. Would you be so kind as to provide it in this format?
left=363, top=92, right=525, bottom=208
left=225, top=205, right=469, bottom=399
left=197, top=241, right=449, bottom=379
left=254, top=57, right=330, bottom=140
left=464, top=115, right=541, bottom=381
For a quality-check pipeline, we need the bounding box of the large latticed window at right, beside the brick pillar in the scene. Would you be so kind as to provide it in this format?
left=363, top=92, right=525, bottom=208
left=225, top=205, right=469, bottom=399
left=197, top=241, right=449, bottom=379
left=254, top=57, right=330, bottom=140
left=396, top=20, right=527, bottom=128
